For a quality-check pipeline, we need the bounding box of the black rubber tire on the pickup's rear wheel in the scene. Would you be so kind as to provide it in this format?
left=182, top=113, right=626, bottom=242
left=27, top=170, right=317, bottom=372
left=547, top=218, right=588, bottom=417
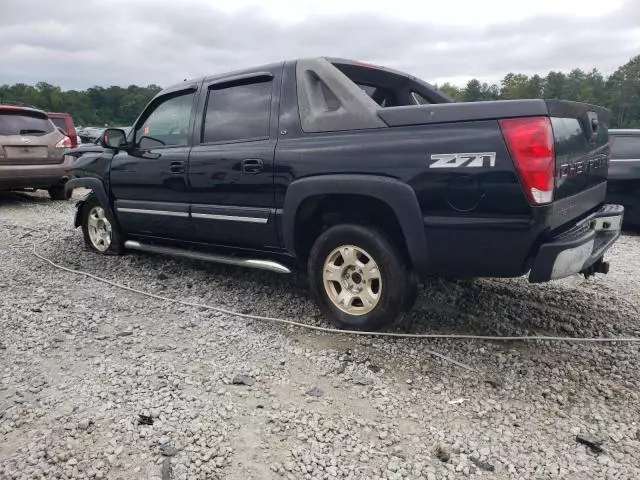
left=307, top=224, right=411, bottom=331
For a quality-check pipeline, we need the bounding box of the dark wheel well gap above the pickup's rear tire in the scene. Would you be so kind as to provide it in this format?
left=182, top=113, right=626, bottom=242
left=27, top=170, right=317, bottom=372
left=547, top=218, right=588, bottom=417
left=294, top=194, right=411, bottom=265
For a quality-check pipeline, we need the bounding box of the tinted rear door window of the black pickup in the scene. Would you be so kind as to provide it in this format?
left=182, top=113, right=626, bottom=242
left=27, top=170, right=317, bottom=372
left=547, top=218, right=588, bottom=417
left=202, top=80, right=272, bottom=143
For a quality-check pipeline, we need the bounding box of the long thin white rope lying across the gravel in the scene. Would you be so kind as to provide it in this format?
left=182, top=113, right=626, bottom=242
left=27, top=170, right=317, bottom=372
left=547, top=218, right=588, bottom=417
left=3, top=224, right=640, bottom=372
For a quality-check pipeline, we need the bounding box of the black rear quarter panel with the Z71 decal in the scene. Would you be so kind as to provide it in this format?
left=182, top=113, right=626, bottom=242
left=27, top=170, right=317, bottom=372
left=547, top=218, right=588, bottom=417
left=274, top=120, right=539, bottom=276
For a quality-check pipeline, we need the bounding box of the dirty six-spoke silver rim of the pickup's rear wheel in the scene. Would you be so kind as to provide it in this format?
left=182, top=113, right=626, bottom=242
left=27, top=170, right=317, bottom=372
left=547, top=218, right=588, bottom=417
left=322, top=245, right=382, bottom=315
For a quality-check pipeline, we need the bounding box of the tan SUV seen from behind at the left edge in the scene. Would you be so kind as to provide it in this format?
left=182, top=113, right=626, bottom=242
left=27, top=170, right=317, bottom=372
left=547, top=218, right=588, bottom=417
left=0, top=105, right=72, bottom=200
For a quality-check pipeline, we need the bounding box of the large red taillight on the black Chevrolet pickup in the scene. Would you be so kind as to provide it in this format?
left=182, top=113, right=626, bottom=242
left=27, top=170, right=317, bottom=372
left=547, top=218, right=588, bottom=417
left=499, top=117, right=556, bottom=205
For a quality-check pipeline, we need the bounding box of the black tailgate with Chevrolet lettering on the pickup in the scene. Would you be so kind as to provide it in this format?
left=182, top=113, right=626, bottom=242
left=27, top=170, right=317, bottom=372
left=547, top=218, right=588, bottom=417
left=547, top=100, right=610, bottom=227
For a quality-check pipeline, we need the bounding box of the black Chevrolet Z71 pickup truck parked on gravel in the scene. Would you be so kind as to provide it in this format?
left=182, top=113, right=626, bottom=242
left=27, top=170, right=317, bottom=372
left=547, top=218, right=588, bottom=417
left=67, top=58, right=623, bottom=329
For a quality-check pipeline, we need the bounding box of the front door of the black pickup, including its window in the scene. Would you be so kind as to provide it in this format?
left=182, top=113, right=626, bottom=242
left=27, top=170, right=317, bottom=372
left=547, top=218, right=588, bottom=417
left=111, top=89, right=195, bottom=239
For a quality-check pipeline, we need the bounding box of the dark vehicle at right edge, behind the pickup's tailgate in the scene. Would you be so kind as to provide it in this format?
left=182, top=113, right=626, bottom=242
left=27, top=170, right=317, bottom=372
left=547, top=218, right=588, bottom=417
left=607, top=129, right=640, bottom=227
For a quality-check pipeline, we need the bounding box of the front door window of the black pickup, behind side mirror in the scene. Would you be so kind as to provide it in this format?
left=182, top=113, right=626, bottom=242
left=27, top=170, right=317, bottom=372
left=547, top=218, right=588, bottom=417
left=135, top=92, right=194, bottom=149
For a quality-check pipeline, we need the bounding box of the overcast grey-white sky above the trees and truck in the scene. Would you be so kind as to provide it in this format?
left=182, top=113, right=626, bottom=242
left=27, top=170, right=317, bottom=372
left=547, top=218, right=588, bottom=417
left=0, top=0, right=640, bottom=89
